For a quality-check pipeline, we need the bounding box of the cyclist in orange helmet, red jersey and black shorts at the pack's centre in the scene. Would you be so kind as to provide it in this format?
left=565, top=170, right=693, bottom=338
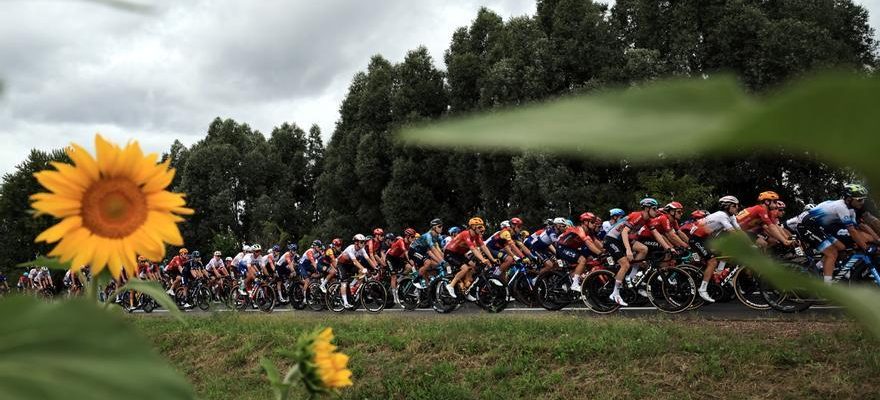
left=443, top=217, right=498, bottom=301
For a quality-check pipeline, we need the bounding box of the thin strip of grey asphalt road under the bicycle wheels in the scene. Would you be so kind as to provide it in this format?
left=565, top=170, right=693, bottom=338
left=132, top=300, right=846, bottom=321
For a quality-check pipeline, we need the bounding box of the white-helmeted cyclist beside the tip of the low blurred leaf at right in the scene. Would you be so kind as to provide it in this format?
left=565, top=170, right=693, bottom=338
left=690, top=196, right=740, bottom=303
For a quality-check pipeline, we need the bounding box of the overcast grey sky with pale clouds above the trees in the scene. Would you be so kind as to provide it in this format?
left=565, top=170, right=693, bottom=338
left=0, top=0, right=880, bottom=173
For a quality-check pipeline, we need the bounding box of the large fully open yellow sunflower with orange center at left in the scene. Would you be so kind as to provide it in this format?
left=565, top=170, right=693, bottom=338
left=31, top=135, right=193, bottom=277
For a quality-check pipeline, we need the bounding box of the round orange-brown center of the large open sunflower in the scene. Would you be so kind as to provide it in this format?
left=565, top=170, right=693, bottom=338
left=82, top=178, right=148, bottom=239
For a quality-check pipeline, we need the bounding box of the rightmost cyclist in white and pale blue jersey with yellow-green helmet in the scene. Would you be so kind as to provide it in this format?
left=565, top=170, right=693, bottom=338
left=799, top=184, right=877, bottom=283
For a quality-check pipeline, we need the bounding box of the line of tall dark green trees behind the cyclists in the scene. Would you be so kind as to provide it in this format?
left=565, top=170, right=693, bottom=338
left=0, top=0, right=878, bottom=276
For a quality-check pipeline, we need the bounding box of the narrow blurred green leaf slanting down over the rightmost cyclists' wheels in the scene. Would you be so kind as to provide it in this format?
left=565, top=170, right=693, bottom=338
left=712, top=235, right=880, bottom=338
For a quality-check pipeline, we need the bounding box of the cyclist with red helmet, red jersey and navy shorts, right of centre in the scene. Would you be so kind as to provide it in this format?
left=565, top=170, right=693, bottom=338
left=556, top=212, right=604, bottom=292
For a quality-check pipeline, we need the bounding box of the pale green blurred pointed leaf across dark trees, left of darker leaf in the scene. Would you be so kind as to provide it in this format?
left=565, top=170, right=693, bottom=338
left=400, top=77, right=753, bottom=158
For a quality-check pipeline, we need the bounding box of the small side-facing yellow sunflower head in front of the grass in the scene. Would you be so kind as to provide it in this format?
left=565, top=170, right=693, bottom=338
left=298, top=328, right=352, bottom=393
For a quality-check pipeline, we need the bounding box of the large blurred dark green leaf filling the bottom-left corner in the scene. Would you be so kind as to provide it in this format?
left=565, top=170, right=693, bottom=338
left=0, top=297, right=194, bottom=400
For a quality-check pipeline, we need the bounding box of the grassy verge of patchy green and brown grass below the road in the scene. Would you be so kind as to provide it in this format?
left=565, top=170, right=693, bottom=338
left=133, top=314, right=880, bottom=399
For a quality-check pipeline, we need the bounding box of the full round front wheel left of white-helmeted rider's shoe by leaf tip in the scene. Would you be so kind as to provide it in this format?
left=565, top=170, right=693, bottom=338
left=646, top=268, right=697, bottom=314
